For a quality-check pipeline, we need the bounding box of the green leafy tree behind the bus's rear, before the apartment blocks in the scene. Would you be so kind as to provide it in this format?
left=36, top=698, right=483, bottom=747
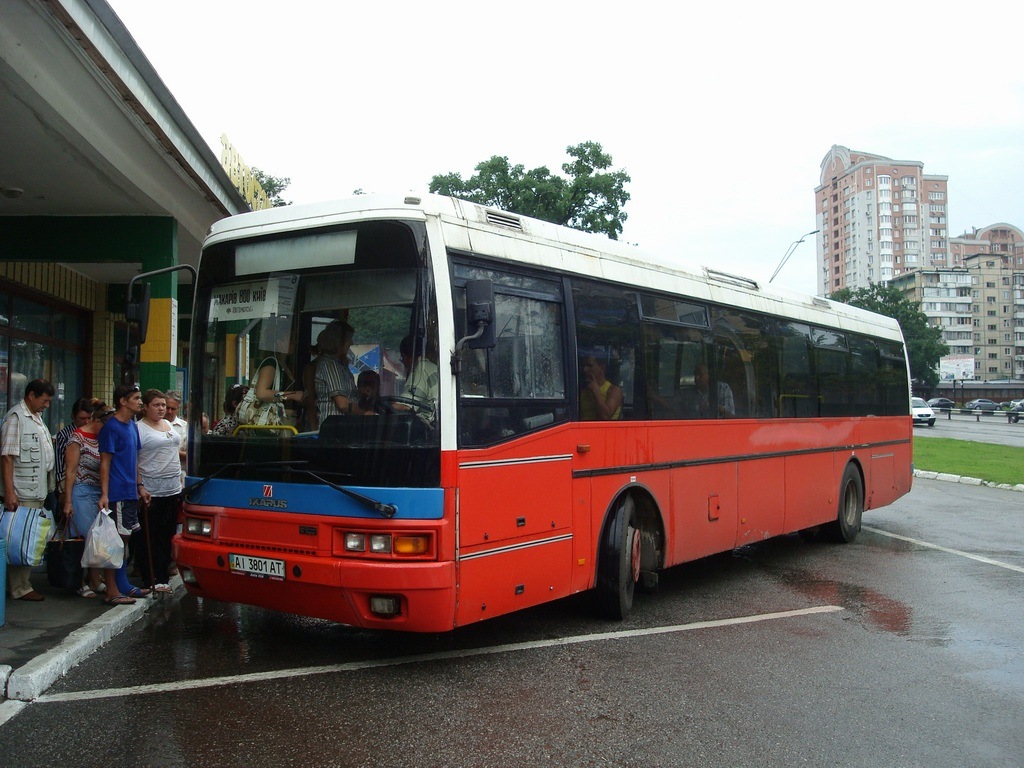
left=830, top=283, right=949, bottom=390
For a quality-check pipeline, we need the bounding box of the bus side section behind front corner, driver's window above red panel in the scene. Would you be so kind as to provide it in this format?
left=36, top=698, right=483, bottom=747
left=455, top=264, right=573, bottom=625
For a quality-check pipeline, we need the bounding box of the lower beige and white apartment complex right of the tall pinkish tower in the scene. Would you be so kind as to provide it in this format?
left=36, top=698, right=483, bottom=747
left=890, top=223, right=1024, bottom=381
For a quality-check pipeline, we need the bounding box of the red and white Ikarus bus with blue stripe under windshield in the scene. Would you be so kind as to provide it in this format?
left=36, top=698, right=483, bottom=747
left=175, top=196, right=912, bottom=632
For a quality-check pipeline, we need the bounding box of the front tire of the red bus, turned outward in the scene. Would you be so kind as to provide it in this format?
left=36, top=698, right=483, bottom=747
left=596, top=494, right=641, bottom=621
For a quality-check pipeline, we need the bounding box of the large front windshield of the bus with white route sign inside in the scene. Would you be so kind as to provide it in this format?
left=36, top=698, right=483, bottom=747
left=190, top=222, right=440, bottom=486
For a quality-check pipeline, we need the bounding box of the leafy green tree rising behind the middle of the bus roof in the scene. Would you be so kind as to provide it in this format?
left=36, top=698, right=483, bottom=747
left=430, top=141, right=631, bottom=240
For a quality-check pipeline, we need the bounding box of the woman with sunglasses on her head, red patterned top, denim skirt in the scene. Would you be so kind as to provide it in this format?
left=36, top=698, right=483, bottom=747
left=63, top=400, right=120, bottom=602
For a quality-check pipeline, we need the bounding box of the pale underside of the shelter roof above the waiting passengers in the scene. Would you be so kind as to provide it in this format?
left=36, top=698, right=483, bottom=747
left=0, top=0, right=243, bottom=283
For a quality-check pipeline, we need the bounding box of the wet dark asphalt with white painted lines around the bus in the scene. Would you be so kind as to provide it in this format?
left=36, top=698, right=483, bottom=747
left=0, top=480, right=1024, bottom=768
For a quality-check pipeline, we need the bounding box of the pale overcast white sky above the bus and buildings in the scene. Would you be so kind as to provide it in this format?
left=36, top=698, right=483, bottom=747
left=108, top=0, right=1024, bottom=294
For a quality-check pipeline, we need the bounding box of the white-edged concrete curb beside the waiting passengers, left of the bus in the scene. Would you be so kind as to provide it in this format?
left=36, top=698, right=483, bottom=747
left=0, top=577, right=184, bottom=701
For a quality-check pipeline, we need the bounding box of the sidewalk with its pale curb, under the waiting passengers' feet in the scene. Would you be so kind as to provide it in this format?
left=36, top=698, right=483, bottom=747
left=0, top=565, right=184, bottom=701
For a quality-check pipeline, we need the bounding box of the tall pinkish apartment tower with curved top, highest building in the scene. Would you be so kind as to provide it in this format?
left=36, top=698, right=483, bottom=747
left=814, top=144, right=962, bottom=296
